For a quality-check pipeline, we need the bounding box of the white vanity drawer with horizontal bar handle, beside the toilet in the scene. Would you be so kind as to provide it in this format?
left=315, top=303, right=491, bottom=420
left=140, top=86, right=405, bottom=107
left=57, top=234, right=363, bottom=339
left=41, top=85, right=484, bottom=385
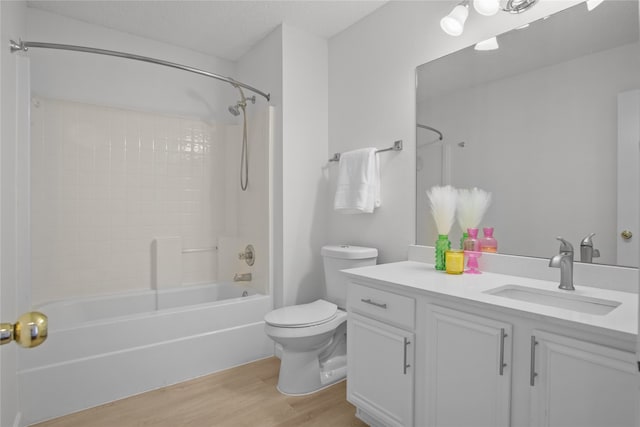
left=347, top=282, right=415, bottom=329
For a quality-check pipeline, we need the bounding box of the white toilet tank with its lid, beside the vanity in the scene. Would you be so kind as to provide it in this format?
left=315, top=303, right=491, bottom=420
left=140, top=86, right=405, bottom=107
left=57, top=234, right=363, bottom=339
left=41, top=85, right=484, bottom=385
left=320, top=245, right=378, bottom=308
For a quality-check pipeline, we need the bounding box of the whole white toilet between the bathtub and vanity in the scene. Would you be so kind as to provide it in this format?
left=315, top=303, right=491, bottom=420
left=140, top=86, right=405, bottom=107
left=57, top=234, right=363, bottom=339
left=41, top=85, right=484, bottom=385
left=264, top=245, right=378, bottom=395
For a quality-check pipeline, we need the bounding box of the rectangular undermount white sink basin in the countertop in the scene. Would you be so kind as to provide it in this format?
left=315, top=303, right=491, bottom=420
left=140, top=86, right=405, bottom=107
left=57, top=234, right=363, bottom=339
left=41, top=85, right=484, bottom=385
left=484, top=285, right=620, bottom=316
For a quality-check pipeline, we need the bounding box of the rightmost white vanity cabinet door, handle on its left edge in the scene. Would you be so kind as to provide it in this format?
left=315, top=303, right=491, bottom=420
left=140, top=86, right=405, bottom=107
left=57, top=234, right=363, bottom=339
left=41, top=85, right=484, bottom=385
left=531, top=331, right=637, bottom=427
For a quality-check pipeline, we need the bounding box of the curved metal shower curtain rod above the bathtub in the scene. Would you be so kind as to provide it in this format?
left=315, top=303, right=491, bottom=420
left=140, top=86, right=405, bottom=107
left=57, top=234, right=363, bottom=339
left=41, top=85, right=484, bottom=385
left=9, top=40, right=271, bottom=101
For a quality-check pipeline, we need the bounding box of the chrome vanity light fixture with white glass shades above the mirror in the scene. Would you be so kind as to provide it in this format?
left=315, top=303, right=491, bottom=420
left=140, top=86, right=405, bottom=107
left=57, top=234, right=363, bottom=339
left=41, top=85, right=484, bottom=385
left=440, top=0, right=536, bottom=36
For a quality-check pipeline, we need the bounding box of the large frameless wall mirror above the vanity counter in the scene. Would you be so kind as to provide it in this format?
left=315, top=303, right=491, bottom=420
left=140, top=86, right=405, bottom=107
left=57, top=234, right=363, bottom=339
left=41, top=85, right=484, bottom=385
left=416, top=0, right=640, bottom=267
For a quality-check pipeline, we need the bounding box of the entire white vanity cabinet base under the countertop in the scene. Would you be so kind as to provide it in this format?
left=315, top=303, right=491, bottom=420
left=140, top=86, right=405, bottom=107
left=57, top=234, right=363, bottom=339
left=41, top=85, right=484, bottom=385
left=347, top=278, right=637, bottom=427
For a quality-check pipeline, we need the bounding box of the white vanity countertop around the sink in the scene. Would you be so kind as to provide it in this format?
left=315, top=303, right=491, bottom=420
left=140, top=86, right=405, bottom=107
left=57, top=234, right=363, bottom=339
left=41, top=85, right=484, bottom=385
left=343, top=261, right=638, bottom=340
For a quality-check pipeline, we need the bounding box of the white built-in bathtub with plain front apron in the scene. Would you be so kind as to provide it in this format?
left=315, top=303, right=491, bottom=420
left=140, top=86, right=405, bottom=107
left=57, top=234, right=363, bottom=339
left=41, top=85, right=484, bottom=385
left=18, top=283, right=273, bottom=425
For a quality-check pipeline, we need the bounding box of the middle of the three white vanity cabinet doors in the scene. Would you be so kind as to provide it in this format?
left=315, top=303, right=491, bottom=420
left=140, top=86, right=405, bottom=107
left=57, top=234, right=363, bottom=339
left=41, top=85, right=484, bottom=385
left=427, top=305, right=512, bottom=427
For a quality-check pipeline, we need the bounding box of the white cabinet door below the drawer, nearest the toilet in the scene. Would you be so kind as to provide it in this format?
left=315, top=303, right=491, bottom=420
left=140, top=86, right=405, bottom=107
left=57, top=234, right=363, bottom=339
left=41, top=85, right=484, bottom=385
left=347, top=313, right=414, bottom=426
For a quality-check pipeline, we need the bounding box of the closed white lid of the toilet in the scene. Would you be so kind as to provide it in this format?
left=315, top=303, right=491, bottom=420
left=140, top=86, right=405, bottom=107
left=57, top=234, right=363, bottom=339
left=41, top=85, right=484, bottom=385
left=264, top=299, right=338, bottom=328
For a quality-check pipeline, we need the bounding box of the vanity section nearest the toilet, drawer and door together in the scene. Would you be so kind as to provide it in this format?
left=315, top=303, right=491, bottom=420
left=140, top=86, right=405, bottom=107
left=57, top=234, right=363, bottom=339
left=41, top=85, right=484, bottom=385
left=347, top=283, right=415, bottom=426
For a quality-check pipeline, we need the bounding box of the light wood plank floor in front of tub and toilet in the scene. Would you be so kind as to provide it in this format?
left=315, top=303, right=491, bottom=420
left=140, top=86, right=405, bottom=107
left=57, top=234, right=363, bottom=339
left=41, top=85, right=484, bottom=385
left=37, top=357, right=365, bottom=427
